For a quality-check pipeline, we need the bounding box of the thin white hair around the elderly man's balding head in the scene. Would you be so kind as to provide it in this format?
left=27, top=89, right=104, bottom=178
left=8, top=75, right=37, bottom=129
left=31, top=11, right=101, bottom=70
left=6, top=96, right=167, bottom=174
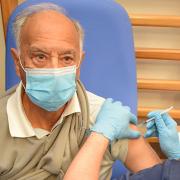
left=13, top=3, right=84, bottom=50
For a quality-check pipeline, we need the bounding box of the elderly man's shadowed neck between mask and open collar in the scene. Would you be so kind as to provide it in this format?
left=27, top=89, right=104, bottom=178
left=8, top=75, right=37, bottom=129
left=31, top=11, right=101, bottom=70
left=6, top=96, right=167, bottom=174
left=22, top=91, right=66, bottom=131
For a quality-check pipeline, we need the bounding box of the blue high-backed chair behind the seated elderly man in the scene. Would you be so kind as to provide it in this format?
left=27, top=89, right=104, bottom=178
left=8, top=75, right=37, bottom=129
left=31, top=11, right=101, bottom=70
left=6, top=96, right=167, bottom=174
left=6, top=0, right=137, bottom=179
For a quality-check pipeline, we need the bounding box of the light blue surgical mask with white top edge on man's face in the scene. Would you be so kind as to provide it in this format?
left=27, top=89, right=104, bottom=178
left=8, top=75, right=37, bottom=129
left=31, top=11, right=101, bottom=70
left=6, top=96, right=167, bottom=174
left=20, top=62, right=76, bottom=111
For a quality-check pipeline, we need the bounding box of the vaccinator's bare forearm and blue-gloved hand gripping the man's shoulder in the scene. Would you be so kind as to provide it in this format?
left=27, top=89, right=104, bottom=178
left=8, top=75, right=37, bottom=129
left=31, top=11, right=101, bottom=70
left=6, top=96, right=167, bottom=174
left=64, top=99, right=140, bottom=180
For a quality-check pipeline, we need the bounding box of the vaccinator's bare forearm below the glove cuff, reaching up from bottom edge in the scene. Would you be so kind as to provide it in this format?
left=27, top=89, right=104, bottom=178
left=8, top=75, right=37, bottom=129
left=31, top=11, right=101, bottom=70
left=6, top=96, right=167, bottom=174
left=64, top=132, right=109, bottom=180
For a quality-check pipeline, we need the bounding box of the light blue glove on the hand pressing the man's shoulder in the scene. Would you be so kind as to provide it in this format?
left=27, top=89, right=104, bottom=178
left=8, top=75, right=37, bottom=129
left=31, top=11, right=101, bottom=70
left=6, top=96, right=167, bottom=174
left=90, top=99, right=140, bottom=141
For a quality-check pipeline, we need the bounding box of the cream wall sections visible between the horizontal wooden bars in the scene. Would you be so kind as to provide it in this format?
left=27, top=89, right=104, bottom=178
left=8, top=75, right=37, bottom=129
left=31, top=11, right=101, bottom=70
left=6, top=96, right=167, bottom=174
left=117, top=0, right=180, bottom=108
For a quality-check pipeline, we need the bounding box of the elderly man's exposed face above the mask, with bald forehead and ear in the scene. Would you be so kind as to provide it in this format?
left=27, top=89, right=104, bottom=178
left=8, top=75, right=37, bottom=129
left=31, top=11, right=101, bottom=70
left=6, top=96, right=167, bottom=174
left=12, top=11, right=82, bottom=82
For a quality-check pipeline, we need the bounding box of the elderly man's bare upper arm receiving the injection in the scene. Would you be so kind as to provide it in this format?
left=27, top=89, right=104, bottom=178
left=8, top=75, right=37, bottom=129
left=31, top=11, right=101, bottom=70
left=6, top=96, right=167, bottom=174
left=125, top=125, right=161, bottom=172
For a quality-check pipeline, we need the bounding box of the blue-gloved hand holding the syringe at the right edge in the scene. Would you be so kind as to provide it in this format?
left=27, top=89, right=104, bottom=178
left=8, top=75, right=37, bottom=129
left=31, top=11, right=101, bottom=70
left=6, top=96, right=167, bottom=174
left=145, top=111, right=180, bottom=159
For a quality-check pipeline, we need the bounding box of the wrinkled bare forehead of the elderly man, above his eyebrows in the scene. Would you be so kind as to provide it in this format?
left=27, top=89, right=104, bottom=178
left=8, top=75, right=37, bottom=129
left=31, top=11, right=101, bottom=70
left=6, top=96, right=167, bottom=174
left=20, top=10, right=79, bottom=46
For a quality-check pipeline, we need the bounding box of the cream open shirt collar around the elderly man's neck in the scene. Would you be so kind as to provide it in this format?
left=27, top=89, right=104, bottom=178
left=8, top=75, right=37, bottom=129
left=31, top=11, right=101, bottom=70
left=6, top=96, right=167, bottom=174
left=7, top=83, right=81, bottom=138
